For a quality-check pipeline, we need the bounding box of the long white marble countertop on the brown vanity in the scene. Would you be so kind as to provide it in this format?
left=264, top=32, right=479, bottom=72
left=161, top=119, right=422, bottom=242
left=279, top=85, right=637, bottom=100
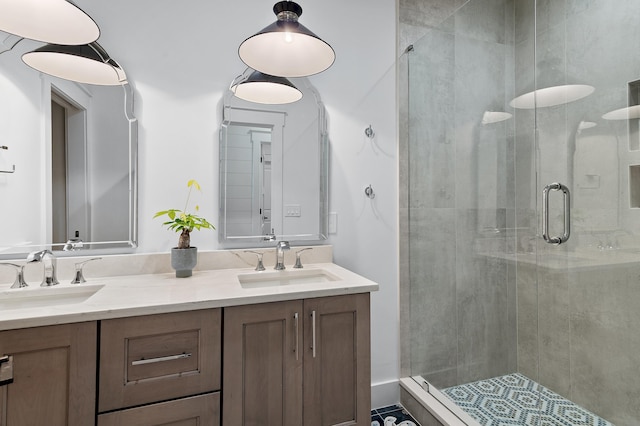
left=0, top=263, right=378, bottom=330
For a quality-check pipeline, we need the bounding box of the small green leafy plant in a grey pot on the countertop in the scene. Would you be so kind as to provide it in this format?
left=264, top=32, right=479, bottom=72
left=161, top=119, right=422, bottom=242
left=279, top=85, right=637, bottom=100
left=153, top=179, right=216, bottom=278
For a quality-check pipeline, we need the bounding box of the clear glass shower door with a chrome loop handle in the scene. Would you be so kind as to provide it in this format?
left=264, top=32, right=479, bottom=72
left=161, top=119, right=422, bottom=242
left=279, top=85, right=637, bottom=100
left=532, top=0, right=640, bottom=426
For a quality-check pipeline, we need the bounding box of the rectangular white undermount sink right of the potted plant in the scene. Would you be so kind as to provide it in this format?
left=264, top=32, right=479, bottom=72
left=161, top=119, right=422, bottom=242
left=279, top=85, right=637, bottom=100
left=238, top=269, right=341, bottom=288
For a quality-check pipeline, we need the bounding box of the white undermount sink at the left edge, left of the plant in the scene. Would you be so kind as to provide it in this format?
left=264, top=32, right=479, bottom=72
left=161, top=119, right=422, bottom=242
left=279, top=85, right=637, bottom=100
left=0, top=284, right=104, bottom=311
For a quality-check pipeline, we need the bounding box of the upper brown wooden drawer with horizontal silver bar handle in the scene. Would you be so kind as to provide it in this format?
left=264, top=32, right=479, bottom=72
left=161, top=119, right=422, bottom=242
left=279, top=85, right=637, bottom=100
left=98, top=309, right=221, bottom=412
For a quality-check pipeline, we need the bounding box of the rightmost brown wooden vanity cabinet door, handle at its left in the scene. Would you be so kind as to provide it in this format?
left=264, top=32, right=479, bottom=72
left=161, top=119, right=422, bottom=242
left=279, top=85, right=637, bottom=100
left=304, top=293, right=371, bottom=426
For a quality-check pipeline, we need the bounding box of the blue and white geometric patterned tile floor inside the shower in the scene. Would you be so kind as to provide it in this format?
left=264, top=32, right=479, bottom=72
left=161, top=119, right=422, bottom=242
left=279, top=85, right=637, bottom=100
left=442, top=373, right=613, bottom=426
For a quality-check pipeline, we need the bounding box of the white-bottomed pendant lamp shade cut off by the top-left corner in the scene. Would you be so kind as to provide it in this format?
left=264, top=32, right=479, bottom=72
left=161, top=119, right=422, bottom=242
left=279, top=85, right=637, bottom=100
left=0, top=0, right=100, bottom=45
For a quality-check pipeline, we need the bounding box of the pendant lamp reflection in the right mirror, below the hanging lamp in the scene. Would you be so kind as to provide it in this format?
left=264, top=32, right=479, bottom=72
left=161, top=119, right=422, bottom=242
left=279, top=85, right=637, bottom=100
left=231, top=71, right=302, bottom=105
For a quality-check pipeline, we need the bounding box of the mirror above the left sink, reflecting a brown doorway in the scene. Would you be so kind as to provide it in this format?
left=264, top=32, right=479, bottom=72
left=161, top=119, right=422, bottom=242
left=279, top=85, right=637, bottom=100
left=0, top=33, right=137, bottom=258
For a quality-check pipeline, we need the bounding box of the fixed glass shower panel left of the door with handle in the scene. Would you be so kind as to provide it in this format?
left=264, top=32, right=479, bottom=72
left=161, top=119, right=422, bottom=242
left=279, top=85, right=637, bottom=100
left=406, top=0, right=536, bottom=412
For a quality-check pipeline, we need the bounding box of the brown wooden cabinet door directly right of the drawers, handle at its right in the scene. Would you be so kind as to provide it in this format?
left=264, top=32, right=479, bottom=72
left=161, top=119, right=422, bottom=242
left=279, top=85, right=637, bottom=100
left=222, top=301, right=302, bottom=426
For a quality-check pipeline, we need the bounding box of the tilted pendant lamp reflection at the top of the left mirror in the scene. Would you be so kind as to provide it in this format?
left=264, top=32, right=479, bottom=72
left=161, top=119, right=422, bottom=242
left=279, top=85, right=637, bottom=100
left=22, top=42, right=127, bottom=86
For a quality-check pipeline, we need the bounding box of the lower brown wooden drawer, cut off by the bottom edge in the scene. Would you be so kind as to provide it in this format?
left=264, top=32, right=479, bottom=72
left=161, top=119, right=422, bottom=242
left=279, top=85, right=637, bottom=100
left=98, top=392, right=220, bottom=426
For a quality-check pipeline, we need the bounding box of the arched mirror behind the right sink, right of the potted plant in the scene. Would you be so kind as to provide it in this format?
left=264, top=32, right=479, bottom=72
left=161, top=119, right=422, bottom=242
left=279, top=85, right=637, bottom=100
left=218, top=78, right=329, bottom=243
